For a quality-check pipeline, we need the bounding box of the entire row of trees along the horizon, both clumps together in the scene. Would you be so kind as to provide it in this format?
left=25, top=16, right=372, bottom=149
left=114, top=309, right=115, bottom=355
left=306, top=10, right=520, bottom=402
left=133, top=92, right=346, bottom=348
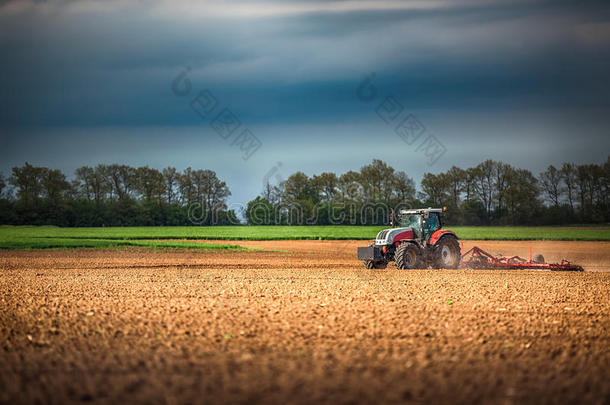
left=0, top=158, right=610, bottom=226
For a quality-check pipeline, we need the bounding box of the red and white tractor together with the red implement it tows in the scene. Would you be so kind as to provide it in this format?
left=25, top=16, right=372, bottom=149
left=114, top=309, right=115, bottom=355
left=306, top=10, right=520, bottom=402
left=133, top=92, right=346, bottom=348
left=358, top=208, right=583, bottom=271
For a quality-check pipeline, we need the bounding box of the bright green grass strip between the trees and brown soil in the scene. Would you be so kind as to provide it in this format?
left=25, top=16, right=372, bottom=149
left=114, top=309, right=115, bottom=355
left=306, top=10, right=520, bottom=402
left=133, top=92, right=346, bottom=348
left=0, top=226, right=610, bottom=249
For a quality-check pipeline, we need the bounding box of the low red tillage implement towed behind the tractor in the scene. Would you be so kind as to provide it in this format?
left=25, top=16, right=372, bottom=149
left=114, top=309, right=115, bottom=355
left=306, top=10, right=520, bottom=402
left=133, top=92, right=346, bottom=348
left=460, top=246, right=584, bottom=271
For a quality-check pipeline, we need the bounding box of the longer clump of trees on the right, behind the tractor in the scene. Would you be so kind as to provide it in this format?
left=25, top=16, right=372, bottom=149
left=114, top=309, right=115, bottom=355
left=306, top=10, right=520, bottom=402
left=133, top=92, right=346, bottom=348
left=245, top=158, right=610, bottom=225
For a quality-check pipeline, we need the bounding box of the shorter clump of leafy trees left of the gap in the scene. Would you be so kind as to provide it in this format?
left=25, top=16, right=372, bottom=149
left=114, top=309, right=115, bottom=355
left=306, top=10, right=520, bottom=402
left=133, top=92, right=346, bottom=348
left=0, top=163, right=239, bottom=226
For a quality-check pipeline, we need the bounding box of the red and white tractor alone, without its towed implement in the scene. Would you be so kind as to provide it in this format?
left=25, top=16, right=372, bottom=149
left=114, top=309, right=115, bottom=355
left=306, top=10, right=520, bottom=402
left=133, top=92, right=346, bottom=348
left=358, top=208, right=462, bottom=269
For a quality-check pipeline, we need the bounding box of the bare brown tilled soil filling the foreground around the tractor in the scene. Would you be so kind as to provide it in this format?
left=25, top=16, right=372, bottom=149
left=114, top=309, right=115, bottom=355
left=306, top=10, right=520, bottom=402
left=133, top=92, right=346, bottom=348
left=0, top=241, right=610, bottom=404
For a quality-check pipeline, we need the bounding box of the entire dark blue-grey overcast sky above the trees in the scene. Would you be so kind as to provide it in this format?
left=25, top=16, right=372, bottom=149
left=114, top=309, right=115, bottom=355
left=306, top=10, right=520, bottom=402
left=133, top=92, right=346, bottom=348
left=0, top=0, right=610, bottom=203
